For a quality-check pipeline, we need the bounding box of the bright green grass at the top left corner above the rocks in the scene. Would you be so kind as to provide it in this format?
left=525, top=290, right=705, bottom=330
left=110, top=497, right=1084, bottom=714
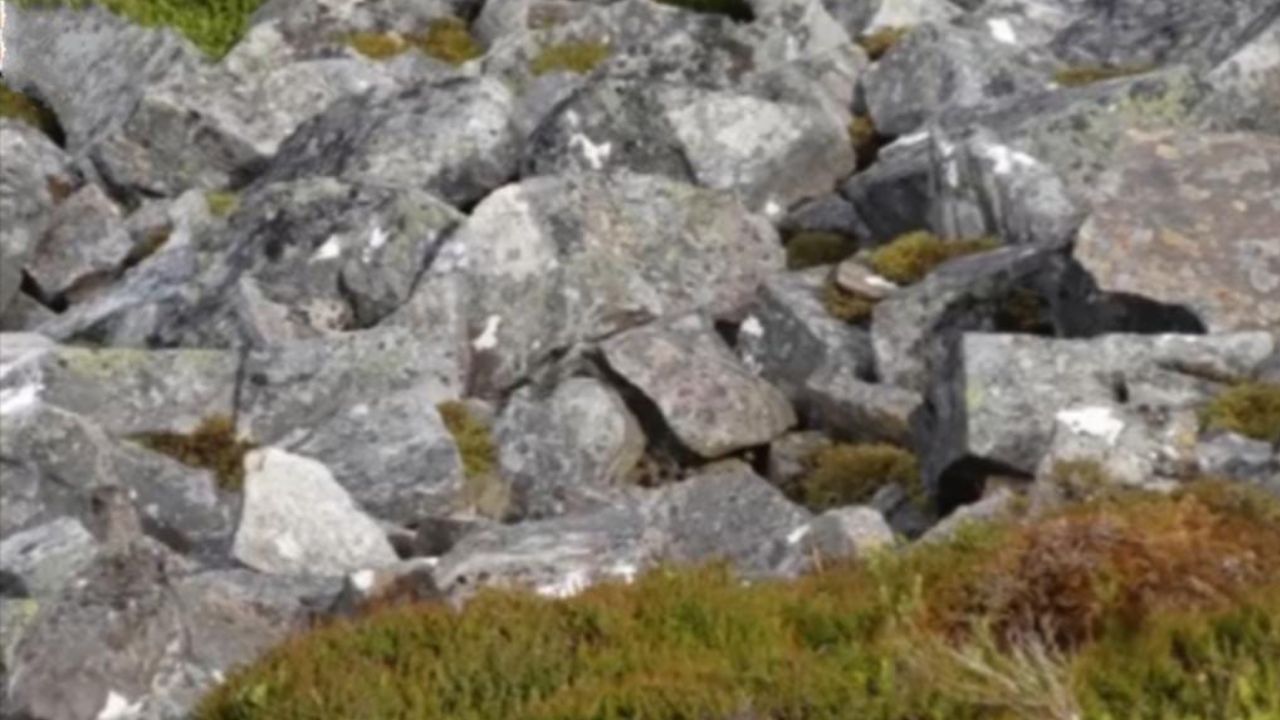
left=17, top=0, right=265, bottom=58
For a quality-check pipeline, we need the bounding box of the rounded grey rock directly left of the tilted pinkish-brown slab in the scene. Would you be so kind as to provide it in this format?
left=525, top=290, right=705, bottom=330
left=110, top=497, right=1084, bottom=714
left=494, top=378, right=645, bottom=519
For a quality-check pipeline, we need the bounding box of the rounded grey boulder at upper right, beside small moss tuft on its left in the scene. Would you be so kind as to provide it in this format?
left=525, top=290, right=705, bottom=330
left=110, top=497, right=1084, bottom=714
left=863, top=24, right=1043, bottom=137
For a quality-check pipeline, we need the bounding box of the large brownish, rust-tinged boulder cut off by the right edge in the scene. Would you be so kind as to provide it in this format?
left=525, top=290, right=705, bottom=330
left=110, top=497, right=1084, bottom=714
left=1075, top=132, right=1280, bottom=332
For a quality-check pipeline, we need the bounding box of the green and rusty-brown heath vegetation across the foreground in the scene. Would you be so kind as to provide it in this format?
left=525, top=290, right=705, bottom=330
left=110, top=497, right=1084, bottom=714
left=195, top=476, right=1280, bottom=720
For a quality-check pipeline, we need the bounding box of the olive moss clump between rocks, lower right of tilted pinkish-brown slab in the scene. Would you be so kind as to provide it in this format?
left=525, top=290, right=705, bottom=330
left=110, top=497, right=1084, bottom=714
left=800, top=443, right=923, bottom=511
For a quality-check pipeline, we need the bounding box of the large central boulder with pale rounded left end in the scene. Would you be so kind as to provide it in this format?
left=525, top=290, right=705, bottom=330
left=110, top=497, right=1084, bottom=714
left=424, top=173, right=783, bottom=396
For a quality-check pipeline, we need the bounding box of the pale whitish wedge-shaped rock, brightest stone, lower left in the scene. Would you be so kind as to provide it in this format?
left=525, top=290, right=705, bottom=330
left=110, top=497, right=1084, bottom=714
left=232, top=448, right=397, bottom=575
